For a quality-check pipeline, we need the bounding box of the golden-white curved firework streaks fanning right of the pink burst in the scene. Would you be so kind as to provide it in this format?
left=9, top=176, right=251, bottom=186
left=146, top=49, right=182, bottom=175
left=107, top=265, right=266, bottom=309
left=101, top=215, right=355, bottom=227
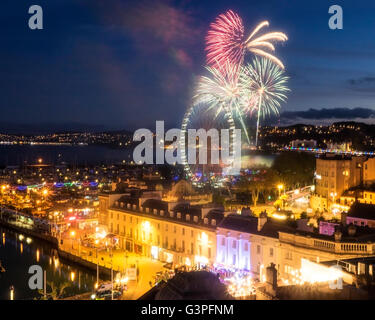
left=244, top=21, right=288, bottom=69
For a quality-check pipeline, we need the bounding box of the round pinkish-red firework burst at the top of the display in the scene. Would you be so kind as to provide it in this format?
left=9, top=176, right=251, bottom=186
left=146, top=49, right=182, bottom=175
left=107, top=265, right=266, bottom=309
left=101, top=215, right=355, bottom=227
left=206, top=10, right=245, bottom=70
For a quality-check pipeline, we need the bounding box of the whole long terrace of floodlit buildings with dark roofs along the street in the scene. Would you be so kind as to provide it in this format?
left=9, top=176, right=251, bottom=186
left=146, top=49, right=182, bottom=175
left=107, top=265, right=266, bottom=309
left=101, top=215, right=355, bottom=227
left=99, top=191, right=375, bottom=283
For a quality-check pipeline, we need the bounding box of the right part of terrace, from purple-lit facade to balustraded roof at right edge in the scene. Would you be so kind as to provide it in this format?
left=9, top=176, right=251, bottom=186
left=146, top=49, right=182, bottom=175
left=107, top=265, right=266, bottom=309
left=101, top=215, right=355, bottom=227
left=216, top=214, right=375, bottom=284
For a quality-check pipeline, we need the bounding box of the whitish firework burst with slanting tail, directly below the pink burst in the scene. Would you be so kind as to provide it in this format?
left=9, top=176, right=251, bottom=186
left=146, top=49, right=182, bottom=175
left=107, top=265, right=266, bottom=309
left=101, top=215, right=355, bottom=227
left=193, top=64, right=250, bottom=143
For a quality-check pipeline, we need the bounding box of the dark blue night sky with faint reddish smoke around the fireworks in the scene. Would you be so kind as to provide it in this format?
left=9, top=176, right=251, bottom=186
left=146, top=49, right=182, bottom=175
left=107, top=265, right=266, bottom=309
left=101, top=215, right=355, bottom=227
left=0, top=0, right=375, bottom=129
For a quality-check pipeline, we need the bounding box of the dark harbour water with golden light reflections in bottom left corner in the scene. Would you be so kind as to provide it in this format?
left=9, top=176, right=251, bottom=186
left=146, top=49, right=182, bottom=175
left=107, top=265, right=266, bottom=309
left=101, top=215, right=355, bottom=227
left=0, top=227, right=96, bottom=300
